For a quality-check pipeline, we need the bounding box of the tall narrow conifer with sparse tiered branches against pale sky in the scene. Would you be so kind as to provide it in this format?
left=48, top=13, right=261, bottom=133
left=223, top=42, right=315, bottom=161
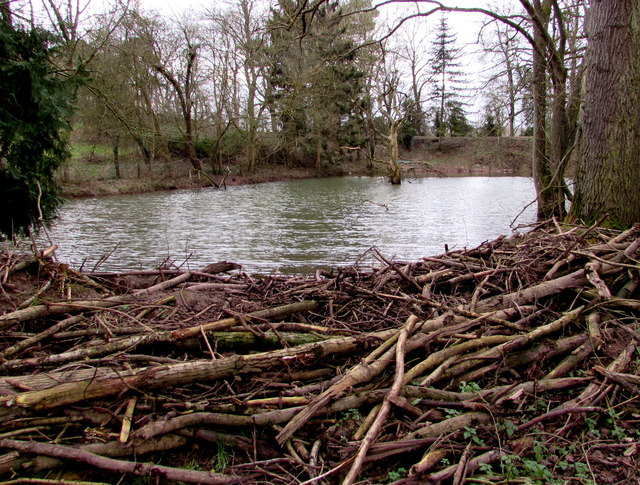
left=430, top=14, right=466, bottom=137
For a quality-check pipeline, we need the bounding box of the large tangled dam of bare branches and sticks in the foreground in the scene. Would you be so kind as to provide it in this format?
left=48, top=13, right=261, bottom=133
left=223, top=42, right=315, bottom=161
left=0, top=223, right=640, bottom=484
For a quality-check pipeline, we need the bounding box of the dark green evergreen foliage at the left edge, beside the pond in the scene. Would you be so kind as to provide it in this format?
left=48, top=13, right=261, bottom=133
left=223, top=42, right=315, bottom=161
left=0, top=16, right=82, bottom=237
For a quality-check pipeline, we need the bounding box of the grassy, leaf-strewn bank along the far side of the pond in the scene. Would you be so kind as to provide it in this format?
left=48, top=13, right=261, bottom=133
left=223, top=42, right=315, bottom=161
left=58, top=137, right=531, bottom=197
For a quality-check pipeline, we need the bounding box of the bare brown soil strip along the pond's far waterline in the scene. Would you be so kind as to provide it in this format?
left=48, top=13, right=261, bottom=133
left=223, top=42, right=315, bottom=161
left=61, top=137, right=532, bottom=197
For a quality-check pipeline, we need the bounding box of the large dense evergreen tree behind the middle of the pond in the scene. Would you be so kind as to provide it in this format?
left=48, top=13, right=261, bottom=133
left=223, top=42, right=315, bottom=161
left=267, top=0, right=364, bottom=168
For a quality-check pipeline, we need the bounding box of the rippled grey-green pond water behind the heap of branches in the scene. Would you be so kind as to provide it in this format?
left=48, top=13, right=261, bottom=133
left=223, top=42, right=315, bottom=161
left=43, top=177, right=535, bottom=273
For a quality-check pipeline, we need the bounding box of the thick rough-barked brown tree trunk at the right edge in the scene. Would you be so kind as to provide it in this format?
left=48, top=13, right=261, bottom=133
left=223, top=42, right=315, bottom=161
left=572, top=0, right=640, bottom=226
